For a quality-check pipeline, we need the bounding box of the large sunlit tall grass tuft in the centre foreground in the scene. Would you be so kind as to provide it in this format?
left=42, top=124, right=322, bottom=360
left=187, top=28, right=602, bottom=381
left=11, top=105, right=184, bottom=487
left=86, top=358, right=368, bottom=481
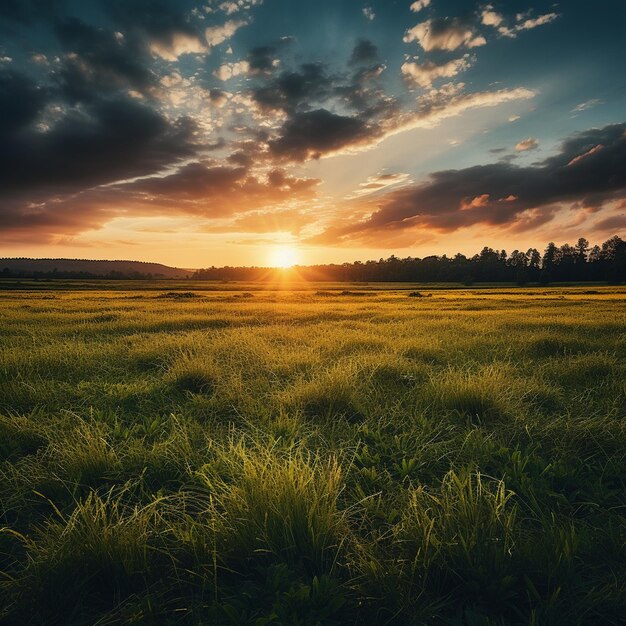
left=200, top=441, right=346, bottom=573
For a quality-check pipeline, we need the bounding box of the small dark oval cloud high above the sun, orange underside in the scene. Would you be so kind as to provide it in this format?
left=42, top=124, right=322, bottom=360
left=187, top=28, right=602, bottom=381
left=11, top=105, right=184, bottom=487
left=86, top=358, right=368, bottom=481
left=269, top=109, right=371, bottom=161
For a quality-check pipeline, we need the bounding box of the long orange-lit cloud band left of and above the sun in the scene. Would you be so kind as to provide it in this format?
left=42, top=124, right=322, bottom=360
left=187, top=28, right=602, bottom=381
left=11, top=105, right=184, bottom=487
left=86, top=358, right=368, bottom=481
left=0, top=155, right=320, bottom=243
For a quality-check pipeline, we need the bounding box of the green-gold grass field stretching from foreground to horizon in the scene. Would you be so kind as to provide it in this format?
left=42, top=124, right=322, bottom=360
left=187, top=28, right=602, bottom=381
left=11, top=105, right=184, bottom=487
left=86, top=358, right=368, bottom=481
left=0, top=282, right=626, bottom=626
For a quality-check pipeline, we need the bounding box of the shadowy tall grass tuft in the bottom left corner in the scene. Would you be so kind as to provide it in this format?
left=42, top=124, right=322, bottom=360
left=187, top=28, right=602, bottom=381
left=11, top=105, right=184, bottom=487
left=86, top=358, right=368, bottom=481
left=3, top=492, right=157, bottom=623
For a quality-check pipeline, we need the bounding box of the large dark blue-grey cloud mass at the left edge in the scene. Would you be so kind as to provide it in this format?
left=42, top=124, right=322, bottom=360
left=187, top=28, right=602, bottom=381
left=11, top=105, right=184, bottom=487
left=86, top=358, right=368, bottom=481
left=0, top=94, right=195, bottom=193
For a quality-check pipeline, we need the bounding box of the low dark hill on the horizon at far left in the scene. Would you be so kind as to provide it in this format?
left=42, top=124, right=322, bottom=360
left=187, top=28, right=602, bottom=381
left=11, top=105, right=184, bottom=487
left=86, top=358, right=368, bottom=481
left=0, top=258, right=193, bottom=278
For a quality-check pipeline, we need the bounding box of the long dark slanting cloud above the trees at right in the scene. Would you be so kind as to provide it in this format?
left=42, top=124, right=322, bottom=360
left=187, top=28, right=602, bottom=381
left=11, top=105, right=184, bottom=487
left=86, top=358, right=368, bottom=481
left=319, top=124, right=626, bottom=241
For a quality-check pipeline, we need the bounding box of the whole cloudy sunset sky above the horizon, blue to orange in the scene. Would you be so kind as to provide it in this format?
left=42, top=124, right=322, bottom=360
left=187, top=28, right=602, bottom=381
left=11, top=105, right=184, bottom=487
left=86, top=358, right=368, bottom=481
left=0, top=0, right=626, bottom=268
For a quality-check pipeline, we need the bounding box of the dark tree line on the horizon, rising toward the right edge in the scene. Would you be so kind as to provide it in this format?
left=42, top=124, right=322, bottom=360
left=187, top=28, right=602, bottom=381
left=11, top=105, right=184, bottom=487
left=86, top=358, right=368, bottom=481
left=192, top=235, right=626, bottom=285
